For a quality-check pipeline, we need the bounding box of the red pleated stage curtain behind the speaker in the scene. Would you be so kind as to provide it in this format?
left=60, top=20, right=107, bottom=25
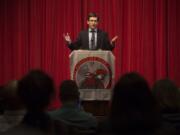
left=0, top=0, right=180, bottom=106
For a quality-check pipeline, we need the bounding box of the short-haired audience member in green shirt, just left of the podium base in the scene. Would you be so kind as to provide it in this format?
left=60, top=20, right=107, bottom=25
left=50, top=80, right=97, bottom=131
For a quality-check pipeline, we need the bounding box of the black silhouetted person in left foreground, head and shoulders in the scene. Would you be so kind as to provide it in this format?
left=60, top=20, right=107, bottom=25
left=1, top=70, right=67, bottom=135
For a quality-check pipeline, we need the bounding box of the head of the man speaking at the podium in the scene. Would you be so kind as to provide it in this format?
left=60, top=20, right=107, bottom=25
left=87, top=12, right=99, bottom=29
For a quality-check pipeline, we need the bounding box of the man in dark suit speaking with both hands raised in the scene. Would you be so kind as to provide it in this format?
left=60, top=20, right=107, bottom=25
left=64, top=13, right=118, bottom=50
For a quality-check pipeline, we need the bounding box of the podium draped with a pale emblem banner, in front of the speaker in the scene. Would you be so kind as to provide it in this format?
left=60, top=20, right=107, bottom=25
left=69, top=50, right=115, bottom=116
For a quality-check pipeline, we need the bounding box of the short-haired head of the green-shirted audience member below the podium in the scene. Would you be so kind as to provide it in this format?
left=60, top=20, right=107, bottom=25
left=59, top=80, right=80, bottom=103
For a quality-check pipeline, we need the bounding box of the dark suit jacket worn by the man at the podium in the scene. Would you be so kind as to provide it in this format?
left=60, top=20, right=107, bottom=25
left=68, top=29, right=114, bottom=50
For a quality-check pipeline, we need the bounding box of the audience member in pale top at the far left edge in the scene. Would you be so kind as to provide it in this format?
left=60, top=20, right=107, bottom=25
left=0, top=80, right=25, bottom=132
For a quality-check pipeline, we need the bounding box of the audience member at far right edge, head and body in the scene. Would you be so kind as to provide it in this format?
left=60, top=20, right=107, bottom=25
left=152, top=79, right=180, bottom=134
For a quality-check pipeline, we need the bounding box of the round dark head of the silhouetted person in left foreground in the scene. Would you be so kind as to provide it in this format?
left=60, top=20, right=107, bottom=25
left=18, top=70, right=54, bottom=110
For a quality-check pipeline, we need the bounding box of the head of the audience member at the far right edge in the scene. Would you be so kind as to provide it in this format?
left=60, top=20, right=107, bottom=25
left=152, top=79, right=180, bottom=112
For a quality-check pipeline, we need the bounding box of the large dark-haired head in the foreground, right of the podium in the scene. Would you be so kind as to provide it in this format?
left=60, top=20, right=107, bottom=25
left=110, top=72, right=160, bottom=132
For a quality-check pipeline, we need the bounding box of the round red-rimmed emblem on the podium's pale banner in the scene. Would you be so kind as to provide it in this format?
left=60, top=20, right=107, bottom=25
left=73, top=57, right=112, bottom=89
